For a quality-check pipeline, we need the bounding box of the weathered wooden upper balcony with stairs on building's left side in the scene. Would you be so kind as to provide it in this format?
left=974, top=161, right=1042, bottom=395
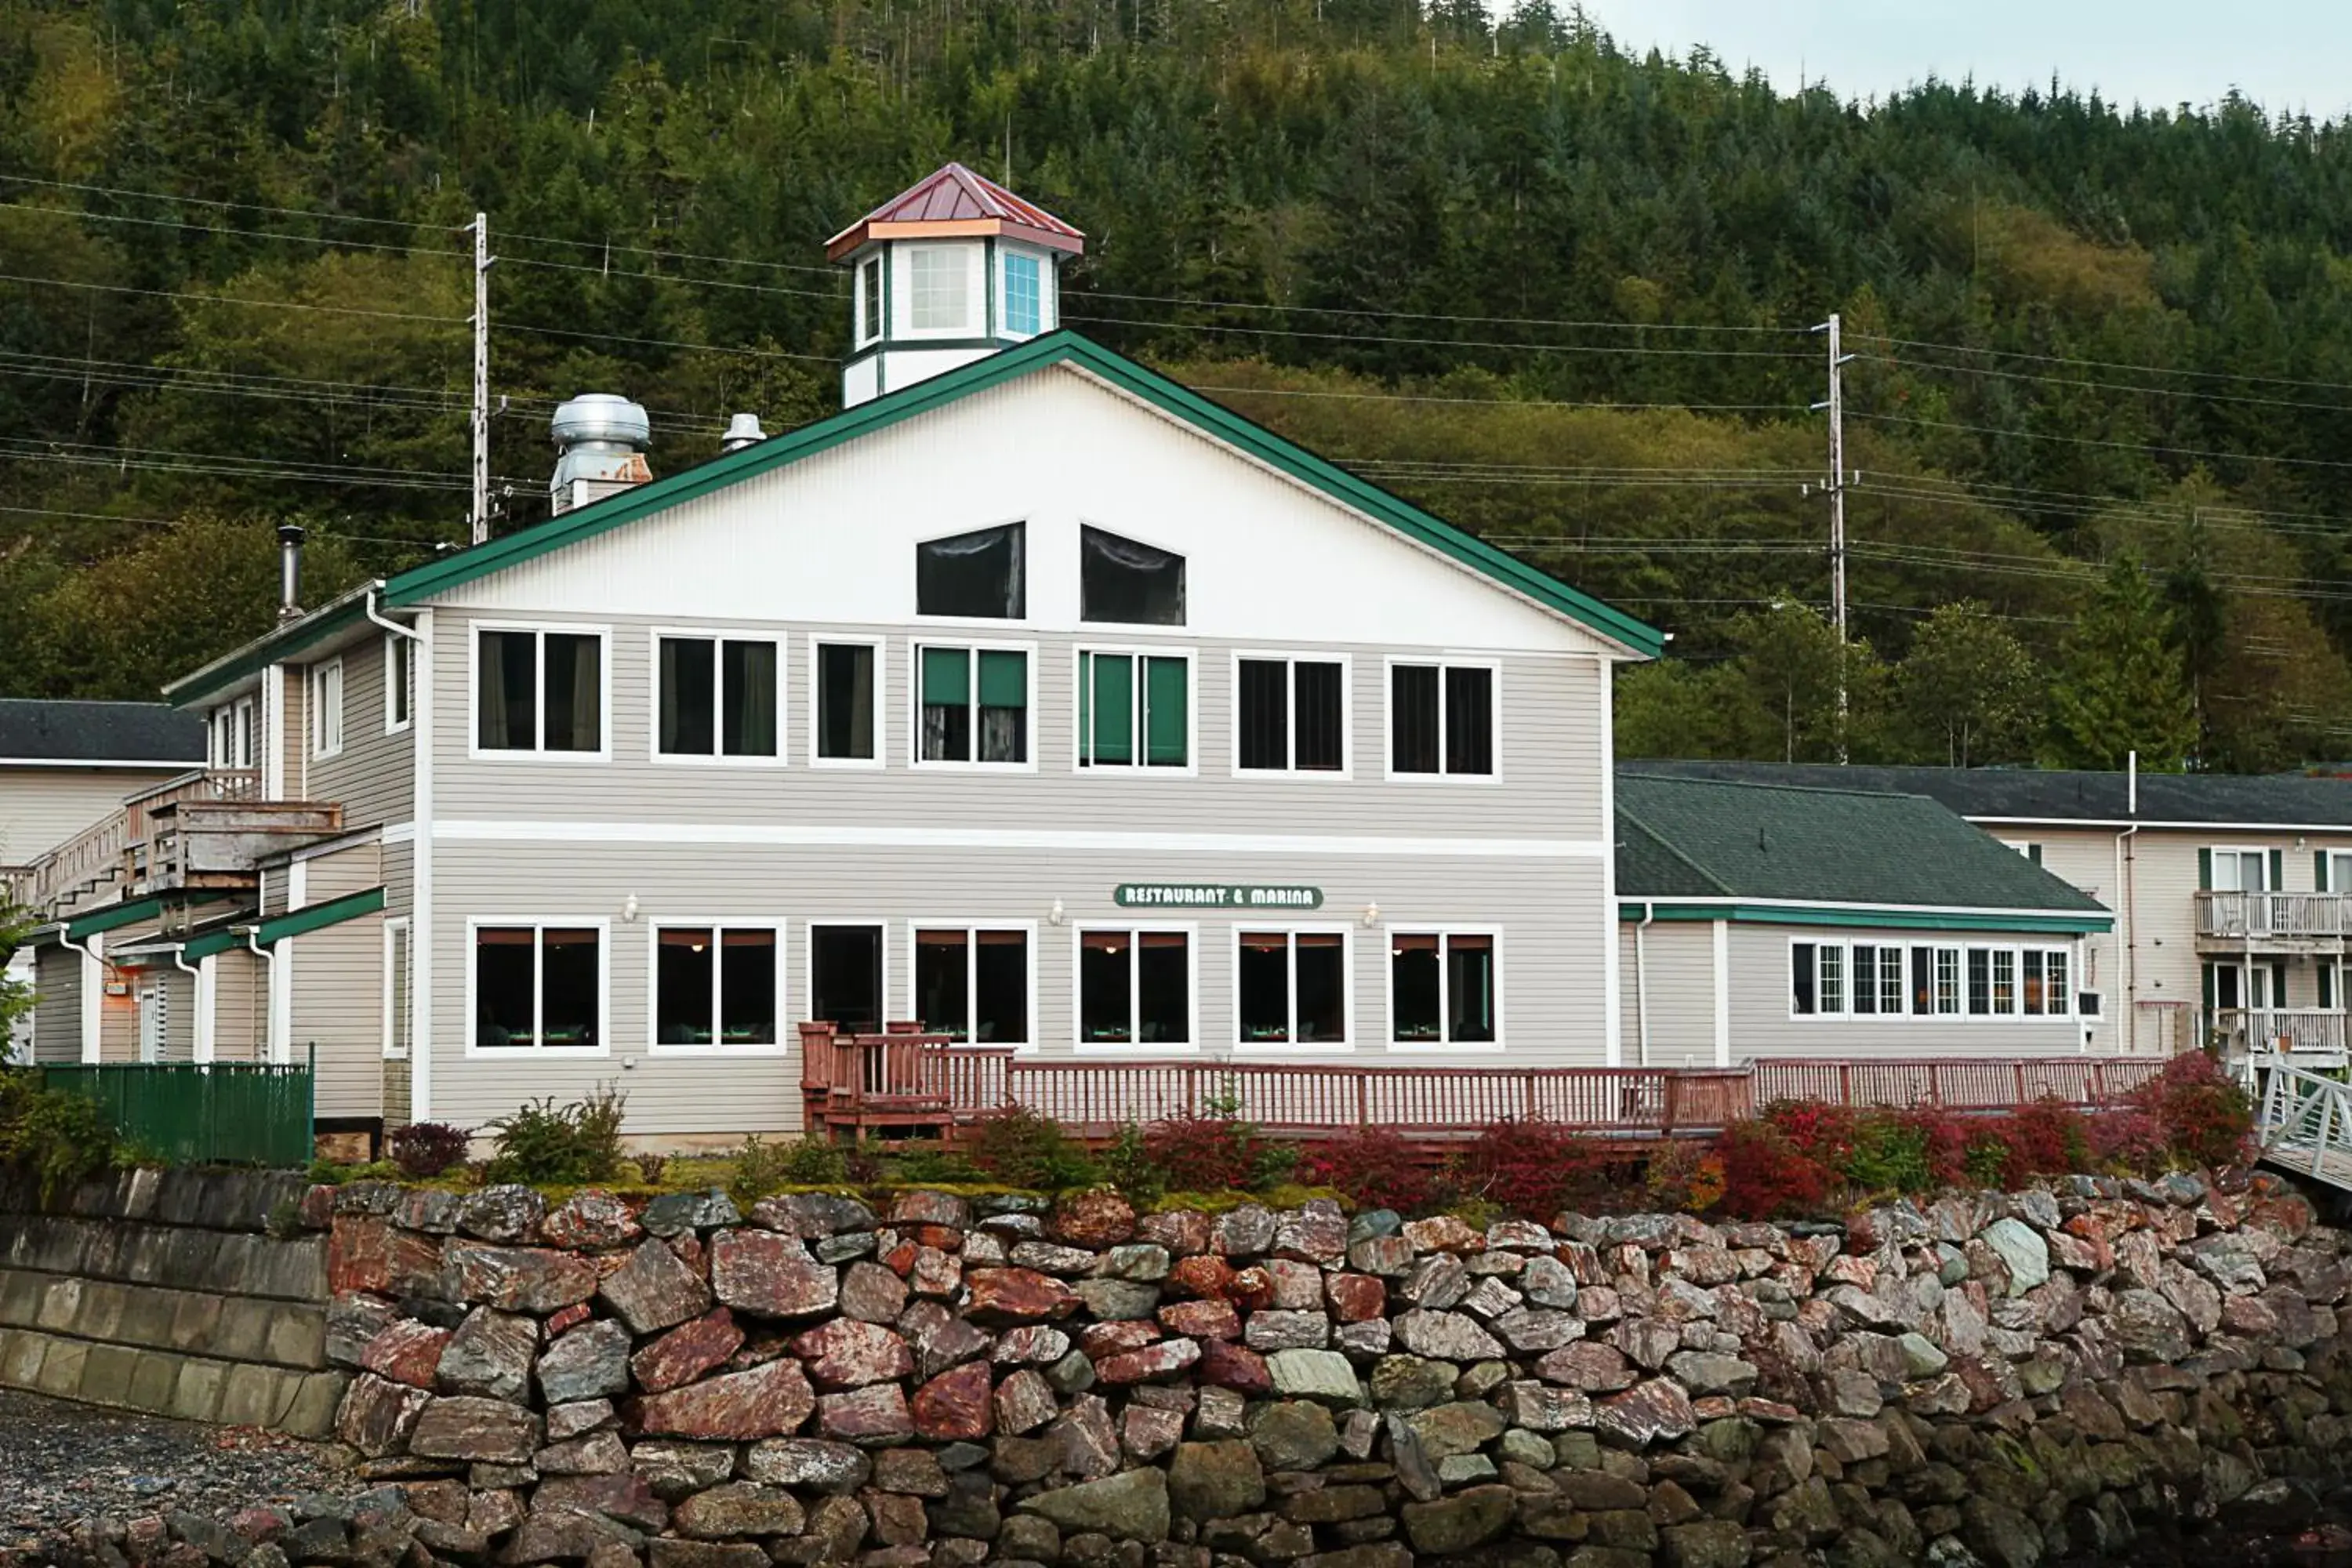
left=9, top=769, right=343, bottom=919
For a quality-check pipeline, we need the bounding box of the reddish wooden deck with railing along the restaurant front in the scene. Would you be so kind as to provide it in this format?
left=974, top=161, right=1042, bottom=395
left=800, top=1025, right=2164, bottom=1140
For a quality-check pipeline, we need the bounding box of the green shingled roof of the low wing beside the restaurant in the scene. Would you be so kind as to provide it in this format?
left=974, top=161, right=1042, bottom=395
left=1616, top=767, right=2107, bottom=924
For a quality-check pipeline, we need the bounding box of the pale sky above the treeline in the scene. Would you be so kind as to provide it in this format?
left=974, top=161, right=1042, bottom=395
left=1562, top=0, right=2352, bottom=120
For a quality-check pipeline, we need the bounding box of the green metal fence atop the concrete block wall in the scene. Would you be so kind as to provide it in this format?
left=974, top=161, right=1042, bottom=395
left=40, top=1062, right=315, bottom=1166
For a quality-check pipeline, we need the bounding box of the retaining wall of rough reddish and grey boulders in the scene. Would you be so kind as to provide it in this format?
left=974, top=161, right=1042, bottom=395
left=13, top=1175, right=2352, bottom=1568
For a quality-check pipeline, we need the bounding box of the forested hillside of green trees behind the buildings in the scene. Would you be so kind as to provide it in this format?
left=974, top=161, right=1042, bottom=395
left=0, top=0, right=2352, bottom=769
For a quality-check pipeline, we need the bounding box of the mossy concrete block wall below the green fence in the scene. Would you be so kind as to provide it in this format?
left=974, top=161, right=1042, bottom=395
left=0, top=1171, right=348, bottom=1436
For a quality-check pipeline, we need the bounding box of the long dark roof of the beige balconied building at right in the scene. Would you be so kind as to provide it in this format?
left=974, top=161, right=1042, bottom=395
left=1639, top=762, right=2352, bottom=827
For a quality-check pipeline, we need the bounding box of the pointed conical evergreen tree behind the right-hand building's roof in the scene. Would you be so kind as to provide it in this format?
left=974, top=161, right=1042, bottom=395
left=2044, top=555, right=2197, bottom=774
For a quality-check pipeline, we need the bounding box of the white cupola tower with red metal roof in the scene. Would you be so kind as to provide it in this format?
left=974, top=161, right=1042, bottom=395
left=826, top=162, right=1087, bottom=409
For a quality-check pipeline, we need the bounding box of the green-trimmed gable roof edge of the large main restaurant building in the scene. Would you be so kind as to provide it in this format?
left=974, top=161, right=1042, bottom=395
left=165, top=332, right=1665, bottom=703
